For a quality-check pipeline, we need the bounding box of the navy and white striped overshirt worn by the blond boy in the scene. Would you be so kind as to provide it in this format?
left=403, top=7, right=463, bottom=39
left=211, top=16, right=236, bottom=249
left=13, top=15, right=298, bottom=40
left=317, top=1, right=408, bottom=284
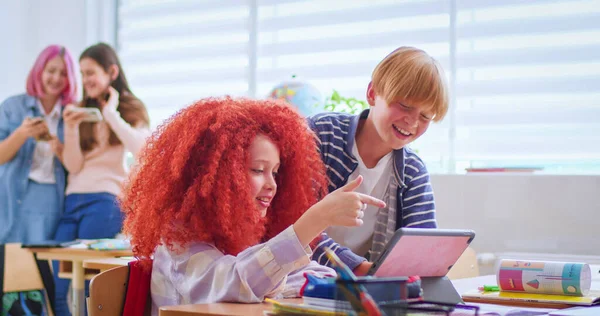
left=308, top=109, right=437, bottom=269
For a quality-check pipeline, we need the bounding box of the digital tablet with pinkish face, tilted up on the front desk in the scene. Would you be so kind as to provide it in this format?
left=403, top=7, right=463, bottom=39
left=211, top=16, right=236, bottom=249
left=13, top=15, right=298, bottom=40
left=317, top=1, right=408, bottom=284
left=368, top=228, right=475, bottom=277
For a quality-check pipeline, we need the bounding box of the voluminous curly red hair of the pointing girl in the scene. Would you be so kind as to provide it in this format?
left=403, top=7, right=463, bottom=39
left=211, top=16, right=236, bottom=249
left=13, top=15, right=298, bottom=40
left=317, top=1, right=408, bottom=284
left=120, top=97, right=327, bottom=266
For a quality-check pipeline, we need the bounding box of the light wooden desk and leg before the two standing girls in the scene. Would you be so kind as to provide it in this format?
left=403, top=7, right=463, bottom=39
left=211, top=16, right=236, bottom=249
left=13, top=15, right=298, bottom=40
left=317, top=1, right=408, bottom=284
left=29, top=248, right=133, bottom=316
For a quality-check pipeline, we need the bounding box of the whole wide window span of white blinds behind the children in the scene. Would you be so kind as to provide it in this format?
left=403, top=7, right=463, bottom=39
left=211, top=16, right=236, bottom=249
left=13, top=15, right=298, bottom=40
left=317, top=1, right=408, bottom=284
left=118, top=0, right=600, bottom=173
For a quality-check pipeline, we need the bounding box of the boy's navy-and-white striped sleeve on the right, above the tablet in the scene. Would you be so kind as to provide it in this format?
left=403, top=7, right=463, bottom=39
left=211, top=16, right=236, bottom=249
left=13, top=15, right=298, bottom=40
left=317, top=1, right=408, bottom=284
left=402, top=152, right=437, bottom=228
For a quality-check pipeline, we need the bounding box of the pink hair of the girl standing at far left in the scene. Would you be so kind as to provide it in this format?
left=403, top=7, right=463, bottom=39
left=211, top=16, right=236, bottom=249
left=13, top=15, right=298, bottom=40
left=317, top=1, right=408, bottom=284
left=26, top=45, right=77, bottom=105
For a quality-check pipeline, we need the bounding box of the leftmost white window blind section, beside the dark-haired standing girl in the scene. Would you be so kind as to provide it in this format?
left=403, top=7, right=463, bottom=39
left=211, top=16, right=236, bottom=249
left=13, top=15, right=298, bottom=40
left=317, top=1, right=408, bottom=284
left=118, top=0, right=250, bottom=126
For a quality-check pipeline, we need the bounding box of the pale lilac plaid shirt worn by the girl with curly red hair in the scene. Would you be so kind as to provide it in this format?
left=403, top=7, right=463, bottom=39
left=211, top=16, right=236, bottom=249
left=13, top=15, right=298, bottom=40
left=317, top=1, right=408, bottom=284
left=150, top=226, right=336, bottom=315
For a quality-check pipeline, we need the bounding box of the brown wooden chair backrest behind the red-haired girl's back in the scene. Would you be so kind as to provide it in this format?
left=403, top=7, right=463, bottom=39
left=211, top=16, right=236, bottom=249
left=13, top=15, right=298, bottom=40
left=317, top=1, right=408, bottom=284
left=88, top=266, right=129, bottom=316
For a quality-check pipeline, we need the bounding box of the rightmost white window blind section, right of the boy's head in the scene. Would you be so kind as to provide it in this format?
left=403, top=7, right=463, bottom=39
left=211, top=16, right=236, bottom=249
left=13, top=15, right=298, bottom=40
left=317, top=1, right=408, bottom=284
left=453, top=0, right=600, bottom=173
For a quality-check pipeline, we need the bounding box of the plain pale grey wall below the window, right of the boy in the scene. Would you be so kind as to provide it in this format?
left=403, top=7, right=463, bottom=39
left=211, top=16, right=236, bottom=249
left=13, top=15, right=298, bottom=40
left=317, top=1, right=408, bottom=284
left=431, top=174, right=600, bottom=260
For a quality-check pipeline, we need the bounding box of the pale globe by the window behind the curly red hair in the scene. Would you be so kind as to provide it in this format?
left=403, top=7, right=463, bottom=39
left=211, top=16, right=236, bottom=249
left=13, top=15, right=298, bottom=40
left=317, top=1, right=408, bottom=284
left=269, top=80, right=323, bottom=116
